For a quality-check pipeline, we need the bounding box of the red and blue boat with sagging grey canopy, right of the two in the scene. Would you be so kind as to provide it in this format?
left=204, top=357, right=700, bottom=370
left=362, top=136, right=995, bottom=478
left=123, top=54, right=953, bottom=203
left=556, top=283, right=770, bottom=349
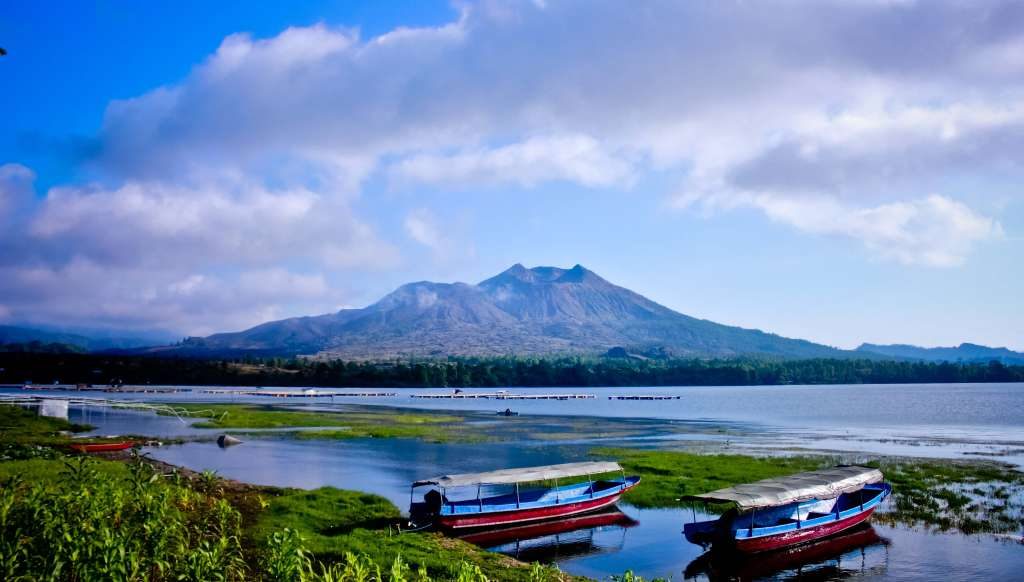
left=683, top=466, right=892, bottom=553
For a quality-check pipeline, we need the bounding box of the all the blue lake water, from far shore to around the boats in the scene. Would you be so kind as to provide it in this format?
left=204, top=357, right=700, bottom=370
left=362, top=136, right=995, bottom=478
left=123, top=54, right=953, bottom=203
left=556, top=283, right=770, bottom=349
left=2, top=384, right=1024, bottom=580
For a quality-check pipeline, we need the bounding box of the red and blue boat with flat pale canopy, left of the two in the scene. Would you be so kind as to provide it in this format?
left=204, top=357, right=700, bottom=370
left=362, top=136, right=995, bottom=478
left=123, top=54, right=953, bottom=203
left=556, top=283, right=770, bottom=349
left=410, top=461, right=640, bottom=530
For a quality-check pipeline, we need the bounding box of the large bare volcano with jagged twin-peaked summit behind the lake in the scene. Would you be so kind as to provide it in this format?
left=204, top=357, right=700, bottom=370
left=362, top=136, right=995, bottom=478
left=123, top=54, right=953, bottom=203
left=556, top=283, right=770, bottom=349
left=157, top=264, right=853, bottom=360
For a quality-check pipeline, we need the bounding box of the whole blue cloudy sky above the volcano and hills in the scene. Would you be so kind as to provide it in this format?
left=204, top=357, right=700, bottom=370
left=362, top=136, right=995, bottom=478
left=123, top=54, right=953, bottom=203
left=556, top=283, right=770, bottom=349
left=0, top=0, right=1024, bottom=349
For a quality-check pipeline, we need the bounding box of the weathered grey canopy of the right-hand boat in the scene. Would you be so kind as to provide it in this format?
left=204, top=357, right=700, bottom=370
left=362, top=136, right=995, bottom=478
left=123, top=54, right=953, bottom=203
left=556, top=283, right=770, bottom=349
left=683, top=466, right=883, bottom=509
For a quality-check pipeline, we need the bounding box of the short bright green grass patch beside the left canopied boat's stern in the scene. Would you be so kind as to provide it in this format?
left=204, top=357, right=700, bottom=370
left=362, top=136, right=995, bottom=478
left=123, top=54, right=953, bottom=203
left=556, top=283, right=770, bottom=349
left=253, top=487, right=561, bottom=581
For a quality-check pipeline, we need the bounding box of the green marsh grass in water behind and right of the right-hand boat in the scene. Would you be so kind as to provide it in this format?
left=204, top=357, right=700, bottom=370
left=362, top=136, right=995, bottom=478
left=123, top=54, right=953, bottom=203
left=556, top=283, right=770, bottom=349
left=593, top=448, right=1024, bottom=534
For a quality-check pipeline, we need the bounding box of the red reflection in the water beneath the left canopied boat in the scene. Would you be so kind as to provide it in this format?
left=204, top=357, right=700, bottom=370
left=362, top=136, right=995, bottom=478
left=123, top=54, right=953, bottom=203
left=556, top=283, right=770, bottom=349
left=460, top=509, right=639, bottom=563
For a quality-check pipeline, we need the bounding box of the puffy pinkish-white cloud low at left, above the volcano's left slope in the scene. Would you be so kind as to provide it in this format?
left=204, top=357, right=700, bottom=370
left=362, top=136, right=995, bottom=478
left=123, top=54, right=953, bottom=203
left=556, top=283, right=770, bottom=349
left=29, top=176, right=393, bottom=266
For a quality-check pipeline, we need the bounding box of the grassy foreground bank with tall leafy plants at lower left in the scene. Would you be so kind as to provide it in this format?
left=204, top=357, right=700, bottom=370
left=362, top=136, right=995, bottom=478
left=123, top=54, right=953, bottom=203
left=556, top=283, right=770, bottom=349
left=0, top=405, right=571, bottom=582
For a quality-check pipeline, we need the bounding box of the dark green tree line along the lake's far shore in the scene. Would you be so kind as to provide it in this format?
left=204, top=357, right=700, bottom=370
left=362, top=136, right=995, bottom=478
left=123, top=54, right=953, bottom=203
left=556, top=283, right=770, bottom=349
left=0, top=351, right=1024, bottom=387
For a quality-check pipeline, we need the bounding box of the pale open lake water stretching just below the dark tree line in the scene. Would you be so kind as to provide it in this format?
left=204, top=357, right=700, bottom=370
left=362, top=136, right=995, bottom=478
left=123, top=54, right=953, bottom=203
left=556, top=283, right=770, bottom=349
left=0, top=383, right=1024, bottom=466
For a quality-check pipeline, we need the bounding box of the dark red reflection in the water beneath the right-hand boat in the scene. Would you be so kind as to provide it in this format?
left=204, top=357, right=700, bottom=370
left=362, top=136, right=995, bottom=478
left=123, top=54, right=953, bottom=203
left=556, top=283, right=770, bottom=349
left=683, top=525, right=889, bottom=581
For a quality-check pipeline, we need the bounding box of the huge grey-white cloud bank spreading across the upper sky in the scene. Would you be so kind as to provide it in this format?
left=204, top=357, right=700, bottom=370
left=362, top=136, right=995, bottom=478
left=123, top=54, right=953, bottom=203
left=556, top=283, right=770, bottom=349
left=88, top=0, right=1024, bottom=264
